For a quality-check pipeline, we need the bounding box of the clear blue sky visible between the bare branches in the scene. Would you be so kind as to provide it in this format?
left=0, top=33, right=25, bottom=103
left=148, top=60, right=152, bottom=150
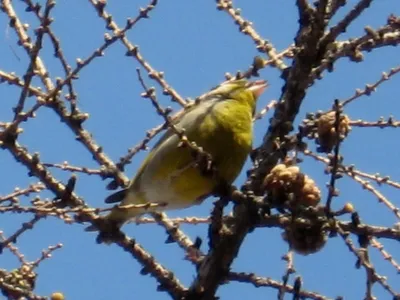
left=0, top=0, right=400, bottom=300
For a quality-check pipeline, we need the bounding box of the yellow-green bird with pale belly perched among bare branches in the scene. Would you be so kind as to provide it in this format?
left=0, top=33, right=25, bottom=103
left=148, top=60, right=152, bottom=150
left=87, top=79, right=267, bottom=230
